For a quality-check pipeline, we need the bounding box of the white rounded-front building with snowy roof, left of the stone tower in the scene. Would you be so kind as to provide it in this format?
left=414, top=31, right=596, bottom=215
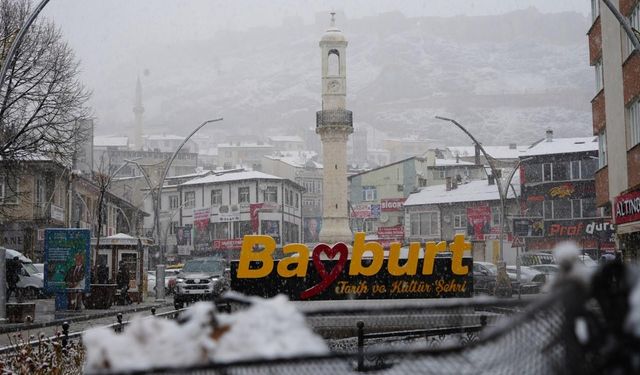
left=176, top=171, right=303, bottom=259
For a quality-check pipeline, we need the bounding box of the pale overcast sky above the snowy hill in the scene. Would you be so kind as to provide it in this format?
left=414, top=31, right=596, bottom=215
left=42, top=0, right=590, bottom=135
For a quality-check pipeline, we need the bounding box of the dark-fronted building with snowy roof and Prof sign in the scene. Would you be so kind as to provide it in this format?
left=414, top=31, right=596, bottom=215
left=520, top=130, right=614, bottom=257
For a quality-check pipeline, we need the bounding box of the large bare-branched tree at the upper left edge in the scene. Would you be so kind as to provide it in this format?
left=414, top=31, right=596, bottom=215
left=0, top=0, right=90, bottom=165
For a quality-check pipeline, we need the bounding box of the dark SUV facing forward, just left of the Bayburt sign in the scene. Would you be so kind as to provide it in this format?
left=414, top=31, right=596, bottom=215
left=173, top=257, right=229, bottom=309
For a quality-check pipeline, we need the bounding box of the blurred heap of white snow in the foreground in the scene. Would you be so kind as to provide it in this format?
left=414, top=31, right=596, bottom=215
left=83, top=296, right=328, bottom=371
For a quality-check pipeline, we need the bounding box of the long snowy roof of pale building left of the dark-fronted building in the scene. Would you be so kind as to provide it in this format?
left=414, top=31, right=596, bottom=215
left=404, top=176, right=520, bottom=206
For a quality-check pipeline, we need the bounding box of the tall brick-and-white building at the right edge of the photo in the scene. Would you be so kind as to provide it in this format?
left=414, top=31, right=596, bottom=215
left=588, top=0, right=640, bottom=262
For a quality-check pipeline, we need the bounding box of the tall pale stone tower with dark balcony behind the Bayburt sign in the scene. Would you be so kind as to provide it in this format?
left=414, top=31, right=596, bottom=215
left=316, top=13, right=353, bottom=244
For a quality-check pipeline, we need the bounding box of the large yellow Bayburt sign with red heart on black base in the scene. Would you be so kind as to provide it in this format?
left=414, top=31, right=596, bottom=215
left=231, top=233, right=473, bottom=300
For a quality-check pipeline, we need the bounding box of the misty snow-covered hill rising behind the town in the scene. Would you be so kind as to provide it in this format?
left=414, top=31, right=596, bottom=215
left=93, top=9, right=595, bottom=144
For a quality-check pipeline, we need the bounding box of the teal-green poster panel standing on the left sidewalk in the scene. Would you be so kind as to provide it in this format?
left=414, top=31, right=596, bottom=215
left=44, top=229, right=91, bottom=292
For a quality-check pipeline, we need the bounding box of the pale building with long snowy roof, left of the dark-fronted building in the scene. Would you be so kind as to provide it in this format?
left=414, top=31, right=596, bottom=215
left=404, top=177, right=520, bottom=264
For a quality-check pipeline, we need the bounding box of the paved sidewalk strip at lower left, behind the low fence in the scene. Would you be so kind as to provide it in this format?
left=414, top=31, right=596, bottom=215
left=0, top=296, right=173, bottom=334
